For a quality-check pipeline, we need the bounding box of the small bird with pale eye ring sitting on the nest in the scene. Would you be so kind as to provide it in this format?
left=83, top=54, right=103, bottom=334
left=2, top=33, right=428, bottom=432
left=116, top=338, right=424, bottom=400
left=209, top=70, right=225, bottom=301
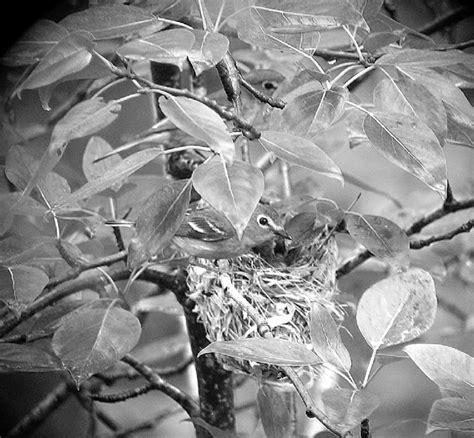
left=172, top=204, right=291, bottom=260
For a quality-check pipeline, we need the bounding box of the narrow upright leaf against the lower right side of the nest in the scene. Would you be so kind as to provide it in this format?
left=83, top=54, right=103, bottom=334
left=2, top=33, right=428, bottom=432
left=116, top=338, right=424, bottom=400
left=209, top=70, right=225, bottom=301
left=311, top=304, right=351, bottom=373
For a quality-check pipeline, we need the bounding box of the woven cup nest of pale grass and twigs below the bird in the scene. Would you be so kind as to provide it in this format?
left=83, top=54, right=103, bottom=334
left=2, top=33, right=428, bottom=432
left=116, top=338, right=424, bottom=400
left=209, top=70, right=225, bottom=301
left=188, top=228, right=342, bottom=380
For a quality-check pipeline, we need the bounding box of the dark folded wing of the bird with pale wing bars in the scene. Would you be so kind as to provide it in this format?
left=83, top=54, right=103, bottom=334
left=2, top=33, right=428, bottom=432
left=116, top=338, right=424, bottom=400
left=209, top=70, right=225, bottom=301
left=176, top=215, right=234, bottom=242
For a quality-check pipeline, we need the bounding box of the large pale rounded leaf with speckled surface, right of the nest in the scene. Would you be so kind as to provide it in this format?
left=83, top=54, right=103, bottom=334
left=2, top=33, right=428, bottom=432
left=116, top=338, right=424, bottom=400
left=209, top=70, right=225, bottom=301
left=356, top=269, right=437, bottom=350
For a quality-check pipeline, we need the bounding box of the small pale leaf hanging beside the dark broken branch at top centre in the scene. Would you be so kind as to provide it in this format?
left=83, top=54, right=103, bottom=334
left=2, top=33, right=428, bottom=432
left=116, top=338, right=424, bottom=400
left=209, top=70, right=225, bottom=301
left=188, top=29, right=229, bottom=76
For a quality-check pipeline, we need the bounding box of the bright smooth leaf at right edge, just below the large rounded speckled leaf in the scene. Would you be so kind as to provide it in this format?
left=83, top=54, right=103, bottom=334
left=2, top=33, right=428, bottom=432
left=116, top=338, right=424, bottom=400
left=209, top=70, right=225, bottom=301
left=404, top=344, right=474, bottom=400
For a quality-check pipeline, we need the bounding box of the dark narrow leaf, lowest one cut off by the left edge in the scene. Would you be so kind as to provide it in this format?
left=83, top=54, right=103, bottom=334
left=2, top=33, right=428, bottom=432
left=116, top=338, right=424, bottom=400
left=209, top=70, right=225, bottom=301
left=0, top=342, right=61, bottom=373
